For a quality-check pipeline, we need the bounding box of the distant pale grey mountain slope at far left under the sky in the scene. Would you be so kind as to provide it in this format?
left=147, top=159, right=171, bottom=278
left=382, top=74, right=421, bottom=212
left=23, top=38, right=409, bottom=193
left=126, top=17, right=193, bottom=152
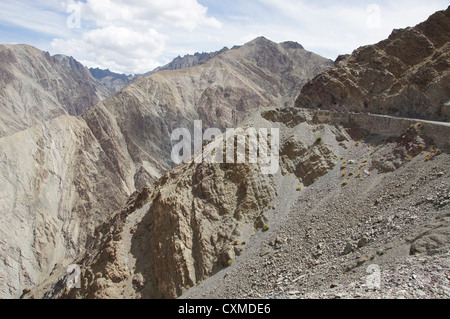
left=0, top=45, right=113, bottom=137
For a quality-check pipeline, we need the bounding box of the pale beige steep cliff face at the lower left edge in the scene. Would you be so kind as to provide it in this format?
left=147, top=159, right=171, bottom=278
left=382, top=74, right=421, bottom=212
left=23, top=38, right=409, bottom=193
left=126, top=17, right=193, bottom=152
left=0, top=116, right=134, bottom=298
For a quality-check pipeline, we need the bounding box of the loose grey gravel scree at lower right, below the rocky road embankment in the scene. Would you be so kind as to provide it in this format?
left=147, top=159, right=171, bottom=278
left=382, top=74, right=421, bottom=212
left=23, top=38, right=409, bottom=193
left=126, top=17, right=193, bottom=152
left=182, top=137, right=450, bottom=299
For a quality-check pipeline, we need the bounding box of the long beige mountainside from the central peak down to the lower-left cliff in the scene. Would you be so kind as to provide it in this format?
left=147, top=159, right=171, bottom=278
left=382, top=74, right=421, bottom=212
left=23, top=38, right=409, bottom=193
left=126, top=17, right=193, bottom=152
left=0, top=38, right=332, bottom=298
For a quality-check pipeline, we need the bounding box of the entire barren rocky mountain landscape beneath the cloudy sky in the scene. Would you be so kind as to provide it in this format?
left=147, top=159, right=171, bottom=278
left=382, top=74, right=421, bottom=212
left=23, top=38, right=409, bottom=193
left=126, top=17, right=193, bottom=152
left=0, top=7, right=450, bottom=299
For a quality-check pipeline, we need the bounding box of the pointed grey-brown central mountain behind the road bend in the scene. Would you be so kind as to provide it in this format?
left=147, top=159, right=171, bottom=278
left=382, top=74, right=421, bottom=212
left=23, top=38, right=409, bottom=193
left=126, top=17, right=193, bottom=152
left=83, top=38, right=332, bottom=189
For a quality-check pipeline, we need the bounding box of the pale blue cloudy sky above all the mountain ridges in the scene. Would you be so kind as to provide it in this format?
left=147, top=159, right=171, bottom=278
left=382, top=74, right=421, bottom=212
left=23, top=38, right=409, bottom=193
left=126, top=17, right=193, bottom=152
left=0, top=0, right=450, bottom=74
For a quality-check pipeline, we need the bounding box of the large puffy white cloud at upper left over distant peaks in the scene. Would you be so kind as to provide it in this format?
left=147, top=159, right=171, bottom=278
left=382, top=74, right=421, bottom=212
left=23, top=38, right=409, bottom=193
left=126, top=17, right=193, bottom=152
left=52, top=0, right=222, bottom=73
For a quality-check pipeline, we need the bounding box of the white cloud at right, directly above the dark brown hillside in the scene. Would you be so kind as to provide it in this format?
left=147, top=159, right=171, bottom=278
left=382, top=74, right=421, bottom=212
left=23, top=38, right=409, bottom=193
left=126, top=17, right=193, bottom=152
left=255, top=0, right=448, bottom=59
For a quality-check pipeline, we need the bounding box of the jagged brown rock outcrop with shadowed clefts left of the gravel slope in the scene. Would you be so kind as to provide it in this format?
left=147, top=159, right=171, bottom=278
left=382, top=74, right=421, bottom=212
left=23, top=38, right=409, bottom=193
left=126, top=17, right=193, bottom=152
left=20, top=158, right=276, bottom=299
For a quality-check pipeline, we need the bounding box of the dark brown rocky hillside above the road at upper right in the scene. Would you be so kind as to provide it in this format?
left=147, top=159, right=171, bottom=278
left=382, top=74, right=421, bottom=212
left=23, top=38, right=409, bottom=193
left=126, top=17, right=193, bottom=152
left=296, top=7, right=450, bottom=121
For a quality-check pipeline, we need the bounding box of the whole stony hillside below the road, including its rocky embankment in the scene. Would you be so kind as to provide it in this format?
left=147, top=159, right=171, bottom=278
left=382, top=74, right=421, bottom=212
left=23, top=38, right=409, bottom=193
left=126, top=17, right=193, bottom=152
left=183, top=109, right=450, bottom=299
